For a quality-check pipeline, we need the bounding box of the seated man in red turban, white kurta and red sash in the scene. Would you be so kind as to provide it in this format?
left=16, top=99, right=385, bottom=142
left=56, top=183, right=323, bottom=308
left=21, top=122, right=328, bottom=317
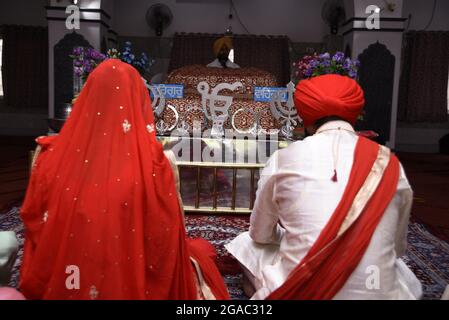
left=227, top=75, right=421, bottom=300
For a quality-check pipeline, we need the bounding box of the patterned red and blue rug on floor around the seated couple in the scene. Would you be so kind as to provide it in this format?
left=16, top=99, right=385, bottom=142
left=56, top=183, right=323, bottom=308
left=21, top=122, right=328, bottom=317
left=0, top=207, right=449, bottom=300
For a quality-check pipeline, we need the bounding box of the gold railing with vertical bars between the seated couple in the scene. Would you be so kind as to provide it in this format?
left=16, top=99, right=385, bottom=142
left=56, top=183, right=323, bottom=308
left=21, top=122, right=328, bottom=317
left=177, top=162, right=264, bottom=214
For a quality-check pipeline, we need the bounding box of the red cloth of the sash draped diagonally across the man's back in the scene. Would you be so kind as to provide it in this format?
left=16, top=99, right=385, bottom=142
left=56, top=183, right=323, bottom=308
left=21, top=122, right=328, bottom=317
left=267, top=137, right=399, bottom=300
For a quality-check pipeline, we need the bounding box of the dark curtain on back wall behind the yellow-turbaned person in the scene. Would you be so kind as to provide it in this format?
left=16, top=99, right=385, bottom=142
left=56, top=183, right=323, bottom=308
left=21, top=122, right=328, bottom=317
left=169, top=33, right=290, bottom=85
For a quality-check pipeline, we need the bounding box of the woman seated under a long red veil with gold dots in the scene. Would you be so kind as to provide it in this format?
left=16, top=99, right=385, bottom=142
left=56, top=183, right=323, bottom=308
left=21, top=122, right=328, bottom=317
left=20, top=59, right=229, bottom=299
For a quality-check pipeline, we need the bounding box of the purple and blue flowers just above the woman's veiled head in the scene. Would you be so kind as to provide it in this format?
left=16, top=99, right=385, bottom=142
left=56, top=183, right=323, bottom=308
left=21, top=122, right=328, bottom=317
left=70, top=41, right=154, bottom=79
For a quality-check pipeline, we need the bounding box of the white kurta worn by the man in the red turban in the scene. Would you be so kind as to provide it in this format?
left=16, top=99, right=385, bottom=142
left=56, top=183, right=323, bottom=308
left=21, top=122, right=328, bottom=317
left=226, top=121, right=421, bottom=299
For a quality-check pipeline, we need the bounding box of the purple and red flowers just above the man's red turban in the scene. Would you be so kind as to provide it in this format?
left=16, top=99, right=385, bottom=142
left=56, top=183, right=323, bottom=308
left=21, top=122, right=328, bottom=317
left=293, top=52, right=360, bottom=80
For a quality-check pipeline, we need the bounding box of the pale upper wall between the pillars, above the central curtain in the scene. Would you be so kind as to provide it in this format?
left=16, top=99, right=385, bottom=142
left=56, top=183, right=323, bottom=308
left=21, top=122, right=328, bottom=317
left=113, top=0, right=328, bottom=42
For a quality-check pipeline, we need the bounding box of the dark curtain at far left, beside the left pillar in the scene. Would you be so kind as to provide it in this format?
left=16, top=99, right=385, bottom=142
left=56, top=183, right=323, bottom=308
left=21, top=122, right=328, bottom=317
left=0, top=25, right=48, bottom=109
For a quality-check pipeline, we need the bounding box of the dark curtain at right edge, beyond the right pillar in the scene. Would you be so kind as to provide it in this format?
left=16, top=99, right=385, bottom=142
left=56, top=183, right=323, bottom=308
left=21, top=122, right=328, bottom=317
left=398, top=31, right=449, bottom=123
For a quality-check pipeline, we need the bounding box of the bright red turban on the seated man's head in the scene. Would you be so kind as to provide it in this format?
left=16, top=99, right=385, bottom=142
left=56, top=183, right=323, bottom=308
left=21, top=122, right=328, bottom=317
left=294, top=74, right=365, bottom=127
